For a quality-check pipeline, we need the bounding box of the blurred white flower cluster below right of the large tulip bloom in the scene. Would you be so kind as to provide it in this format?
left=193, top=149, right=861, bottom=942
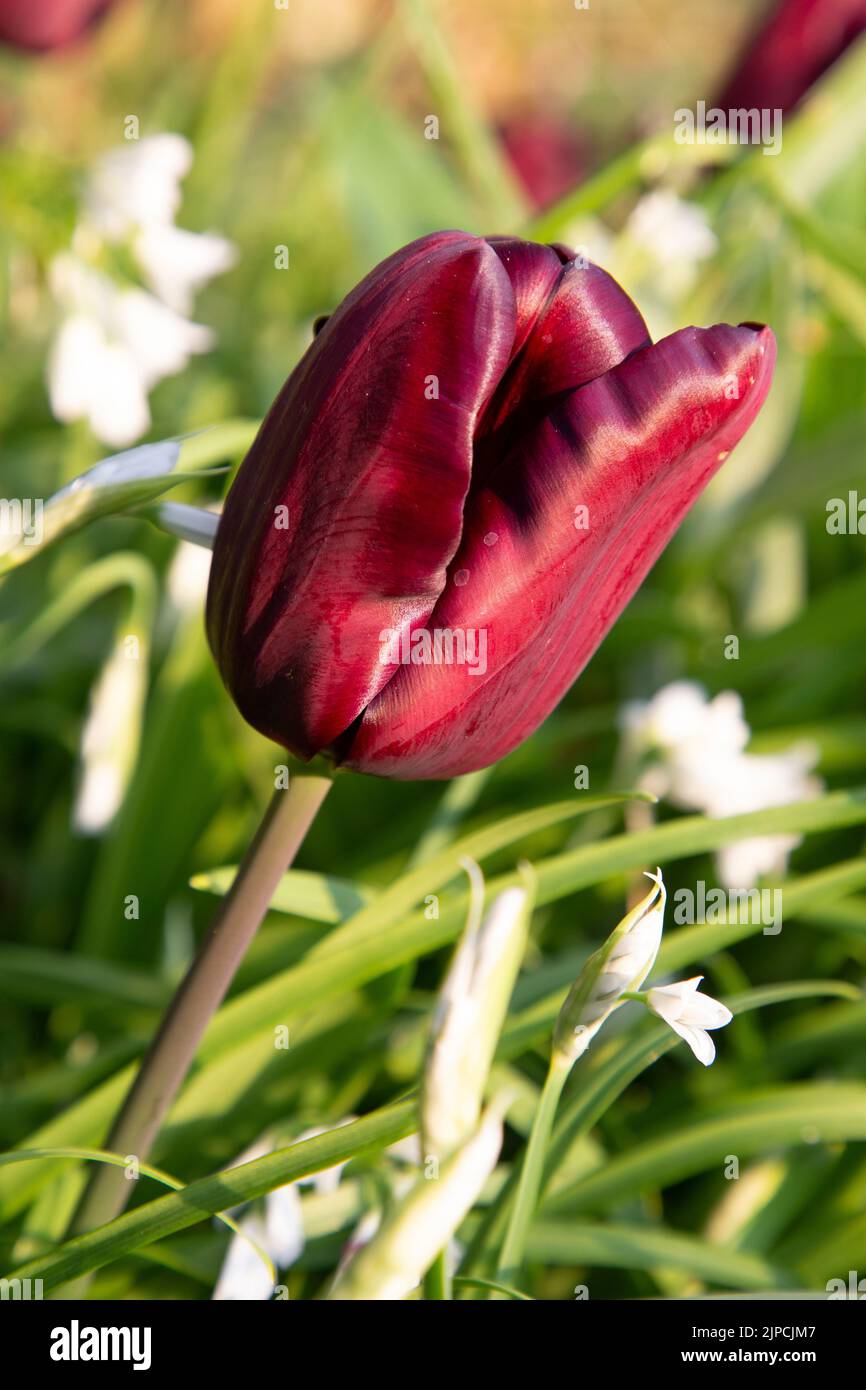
left=621, top=681, right=823, bottom=888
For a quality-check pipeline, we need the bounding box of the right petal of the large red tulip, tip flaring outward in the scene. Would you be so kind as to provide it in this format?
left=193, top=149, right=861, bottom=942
left=345, top=325, right=776, bottom=778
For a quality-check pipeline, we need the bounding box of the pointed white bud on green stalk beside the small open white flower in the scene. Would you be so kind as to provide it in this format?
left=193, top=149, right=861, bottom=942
left=553, top=869, right=667, bottom=1066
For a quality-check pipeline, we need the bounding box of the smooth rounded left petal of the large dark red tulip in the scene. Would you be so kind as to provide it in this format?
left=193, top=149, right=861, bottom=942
left=207, top=232, right=516, bottom=756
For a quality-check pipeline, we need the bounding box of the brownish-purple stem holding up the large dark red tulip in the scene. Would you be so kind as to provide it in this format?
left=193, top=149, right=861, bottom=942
left=72, top=777, right=331, bottom=1233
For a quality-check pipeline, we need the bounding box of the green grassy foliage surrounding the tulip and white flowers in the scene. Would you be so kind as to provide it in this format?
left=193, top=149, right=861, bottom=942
left=0, top=0, right=866, bottom=1298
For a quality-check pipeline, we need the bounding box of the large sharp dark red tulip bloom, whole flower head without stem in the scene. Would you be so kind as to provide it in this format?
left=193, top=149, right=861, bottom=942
left=207, top=232, right=776, bottom=778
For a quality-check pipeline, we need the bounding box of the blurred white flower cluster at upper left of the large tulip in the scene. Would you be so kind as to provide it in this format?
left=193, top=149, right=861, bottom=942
left=47, top=135, right=235, bottom=448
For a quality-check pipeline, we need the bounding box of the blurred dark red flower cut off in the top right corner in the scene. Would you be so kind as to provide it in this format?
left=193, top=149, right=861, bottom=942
left=714, top=0, right=866, bottom=111
